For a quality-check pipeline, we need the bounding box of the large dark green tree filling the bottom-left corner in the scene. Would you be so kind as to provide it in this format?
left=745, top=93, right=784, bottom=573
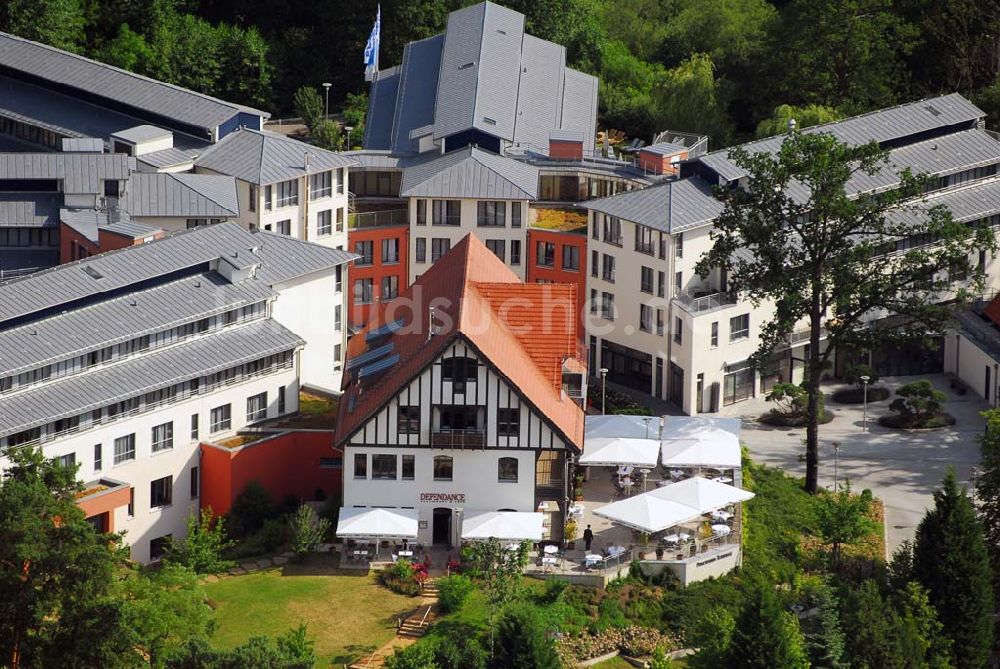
left=0, top=447, right=140, bottom=669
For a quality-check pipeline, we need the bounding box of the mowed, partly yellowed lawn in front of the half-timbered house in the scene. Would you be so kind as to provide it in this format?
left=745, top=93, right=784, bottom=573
left=205, top=558, right=419, bottom=667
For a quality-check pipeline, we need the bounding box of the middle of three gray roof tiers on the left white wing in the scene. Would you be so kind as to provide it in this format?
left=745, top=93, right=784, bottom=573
left=0, top=272, right=274, bottom=376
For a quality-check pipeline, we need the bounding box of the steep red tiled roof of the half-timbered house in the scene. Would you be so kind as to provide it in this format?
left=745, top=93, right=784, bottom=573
left=336, top=235, right=583, bottom=449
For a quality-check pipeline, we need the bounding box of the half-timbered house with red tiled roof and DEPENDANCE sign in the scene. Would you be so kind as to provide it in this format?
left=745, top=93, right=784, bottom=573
left=336, top=235, right=586, bottom=544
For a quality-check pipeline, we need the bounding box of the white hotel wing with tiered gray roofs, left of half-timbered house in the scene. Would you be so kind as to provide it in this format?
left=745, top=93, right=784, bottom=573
left=0, top=223, right=353, bottom=562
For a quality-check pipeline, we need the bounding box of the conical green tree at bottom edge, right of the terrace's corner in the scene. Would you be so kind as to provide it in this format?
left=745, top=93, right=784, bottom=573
left=722, top=583, right=809, bottom=669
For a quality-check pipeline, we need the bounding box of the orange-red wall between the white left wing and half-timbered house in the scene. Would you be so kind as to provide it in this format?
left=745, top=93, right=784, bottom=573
left=201, top=432, right=343, bottom=515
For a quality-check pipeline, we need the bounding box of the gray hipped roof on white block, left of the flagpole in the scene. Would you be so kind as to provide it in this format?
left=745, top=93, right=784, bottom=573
left=195, top=128, right=354, bottom=185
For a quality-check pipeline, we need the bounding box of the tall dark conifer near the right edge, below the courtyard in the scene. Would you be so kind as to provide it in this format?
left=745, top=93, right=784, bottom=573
left=913, top=468, right=994, bottom=667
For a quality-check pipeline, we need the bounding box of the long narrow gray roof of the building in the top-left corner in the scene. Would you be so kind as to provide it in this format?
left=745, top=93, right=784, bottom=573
left=0, top=33, right=269, bottom=130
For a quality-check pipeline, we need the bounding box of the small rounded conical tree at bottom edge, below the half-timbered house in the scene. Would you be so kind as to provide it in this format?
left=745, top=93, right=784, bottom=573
left=491, top=602, right=562, bottom=669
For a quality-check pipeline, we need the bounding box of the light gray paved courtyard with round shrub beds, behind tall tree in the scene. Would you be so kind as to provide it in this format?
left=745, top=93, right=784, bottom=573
left=721, top=374, right=988, bottom=554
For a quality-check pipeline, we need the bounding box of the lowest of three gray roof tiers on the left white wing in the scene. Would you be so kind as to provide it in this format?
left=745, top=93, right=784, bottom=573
left=0, top=319, right=304, bottom=435
